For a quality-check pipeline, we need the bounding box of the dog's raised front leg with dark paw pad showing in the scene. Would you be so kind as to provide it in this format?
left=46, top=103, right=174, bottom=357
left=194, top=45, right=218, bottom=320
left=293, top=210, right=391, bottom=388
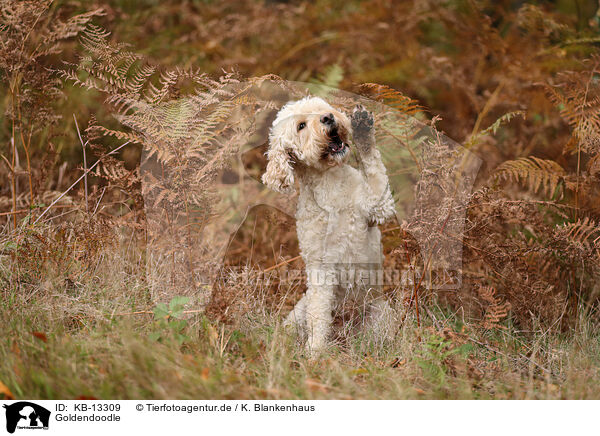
left=351, top=105, right=395, bottom=224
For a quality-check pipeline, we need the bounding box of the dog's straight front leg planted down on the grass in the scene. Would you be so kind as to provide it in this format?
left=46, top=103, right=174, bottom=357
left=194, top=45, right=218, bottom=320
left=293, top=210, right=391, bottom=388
left=306, top=269, right=335, bottom=356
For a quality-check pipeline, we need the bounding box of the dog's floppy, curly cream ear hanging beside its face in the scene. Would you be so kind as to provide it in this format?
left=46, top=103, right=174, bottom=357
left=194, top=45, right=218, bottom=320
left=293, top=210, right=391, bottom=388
left=262, top=136, right=294, bottom=194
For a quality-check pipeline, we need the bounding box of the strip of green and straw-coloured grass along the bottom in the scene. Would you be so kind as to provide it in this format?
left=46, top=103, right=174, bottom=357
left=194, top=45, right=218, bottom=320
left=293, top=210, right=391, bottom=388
left=0, top=240, right=600, bottom=399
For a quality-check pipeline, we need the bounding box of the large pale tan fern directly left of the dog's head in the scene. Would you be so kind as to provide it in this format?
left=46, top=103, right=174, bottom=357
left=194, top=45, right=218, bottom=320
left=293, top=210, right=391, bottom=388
left=60, top=26, right=296, bottom=296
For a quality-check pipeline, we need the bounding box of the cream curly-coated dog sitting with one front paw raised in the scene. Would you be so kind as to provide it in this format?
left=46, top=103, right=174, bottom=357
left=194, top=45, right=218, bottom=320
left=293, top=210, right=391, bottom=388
left=262, top=97, right=395, bottom=353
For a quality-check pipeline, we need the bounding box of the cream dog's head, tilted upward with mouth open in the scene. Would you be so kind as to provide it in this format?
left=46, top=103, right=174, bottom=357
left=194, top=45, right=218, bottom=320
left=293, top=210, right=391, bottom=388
left=262, top=97, right=351, bottom=193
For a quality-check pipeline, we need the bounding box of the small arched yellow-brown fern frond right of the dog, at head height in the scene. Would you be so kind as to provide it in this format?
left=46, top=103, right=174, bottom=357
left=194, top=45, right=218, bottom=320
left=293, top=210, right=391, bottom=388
left=492, top=156, right=565, bottom=196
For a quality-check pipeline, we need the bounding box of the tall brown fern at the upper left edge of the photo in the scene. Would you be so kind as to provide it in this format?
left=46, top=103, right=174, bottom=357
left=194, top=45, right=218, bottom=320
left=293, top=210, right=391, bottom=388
left=0, top=0, right=103, bottom=215
